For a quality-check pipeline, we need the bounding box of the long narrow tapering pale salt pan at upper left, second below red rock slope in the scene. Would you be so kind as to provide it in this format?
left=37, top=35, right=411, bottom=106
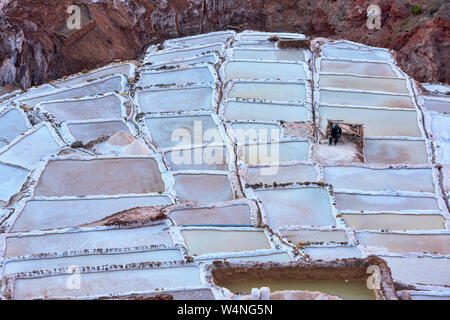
left=19, top=76, right=125, bottom=106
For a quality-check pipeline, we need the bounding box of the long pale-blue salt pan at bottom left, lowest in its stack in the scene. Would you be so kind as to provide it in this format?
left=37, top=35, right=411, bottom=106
left=14, top=267, right=202, bottom=299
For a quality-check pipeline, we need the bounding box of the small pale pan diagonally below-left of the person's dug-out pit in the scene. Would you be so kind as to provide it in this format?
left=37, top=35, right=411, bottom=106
left=245, top=164, right=318, bottom=184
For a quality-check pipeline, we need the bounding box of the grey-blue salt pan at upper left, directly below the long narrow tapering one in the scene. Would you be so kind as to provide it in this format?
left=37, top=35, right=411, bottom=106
left=40, top=94, right=123, bottom=121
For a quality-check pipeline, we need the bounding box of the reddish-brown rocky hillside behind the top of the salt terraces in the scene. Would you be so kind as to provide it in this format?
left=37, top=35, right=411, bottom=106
left=0, top=0, right=450, bottom=88
